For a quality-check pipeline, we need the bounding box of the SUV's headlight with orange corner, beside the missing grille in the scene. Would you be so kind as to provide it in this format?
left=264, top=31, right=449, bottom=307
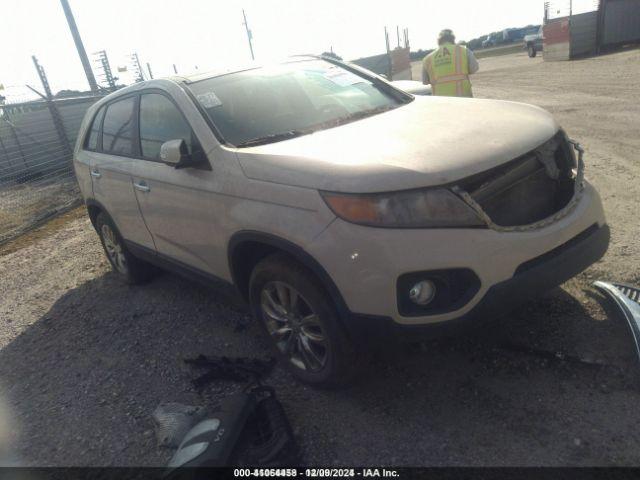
left=322, top=188, right=486, bottom=228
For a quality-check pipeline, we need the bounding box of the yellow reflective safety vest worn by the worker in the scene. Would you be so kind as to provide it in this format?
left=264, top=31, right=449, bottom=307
left=423, top=43, right=473, bottom=97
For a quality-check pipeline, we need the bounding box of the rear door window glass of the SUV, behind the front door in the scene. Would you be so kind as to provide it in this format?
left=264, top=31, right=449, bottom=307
left=102, top=97, right=135, bottom=155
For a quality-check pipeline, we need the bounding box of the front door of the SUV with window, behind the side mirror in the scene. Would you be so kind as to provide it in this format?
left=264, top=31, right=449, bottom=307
left=133, top=90, right=227, bottom=276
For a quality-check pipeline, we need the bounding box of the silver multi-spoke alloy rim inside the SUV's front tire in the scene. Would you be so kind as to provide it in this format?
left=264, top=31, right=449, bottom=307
left=260, top=281, right=329, bottom=372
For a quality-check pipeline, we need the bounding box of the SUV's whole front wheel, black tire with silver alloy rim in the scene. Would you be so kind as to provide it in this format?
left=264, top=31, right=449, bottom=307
left=249, top=254, right=359, bottom=388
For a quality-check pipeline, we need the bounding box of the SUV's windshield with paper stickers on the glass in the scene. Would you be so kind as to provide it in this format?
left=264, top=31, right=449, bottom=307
left=189, top=60, right=402, bottom=147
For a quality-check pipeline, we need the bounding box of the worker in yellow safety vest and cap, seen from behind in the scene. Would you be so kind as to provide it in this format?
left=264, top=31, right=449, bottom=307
left=422, top=29, right=480, bottom=97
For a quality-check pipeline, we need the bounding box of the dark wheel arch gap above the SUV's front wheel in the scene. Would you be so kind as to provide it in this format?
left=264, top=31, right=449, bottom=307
left=227, top=231, right=349, bottom=319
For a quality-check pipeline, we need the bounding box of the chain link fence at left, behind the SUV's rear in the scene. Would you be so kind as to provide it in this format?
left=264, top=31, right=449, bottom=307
left=0, top=96, right=101, bottom=243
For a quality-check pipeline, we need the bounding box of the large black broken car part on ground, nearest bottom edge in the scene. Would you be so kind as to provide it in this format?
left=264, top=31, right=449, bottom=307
left=167, top=386, right=299, bottom=470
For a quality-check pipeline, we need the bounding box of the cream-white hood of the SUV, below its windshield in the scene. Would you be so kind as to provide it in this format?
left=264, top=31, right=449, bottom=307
left=236, top=97, right=558, bottom=193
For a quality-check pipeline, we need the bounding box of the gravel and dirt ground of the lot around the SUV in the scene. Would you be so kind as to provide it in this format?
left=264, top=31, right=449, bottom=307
left=0, top=50, right=640, bottom=465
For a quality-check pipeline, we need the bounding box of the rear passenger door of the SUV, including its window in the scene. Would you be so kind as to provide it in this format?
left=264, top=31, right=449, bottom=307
left=89, top=95, right=154, bottom=249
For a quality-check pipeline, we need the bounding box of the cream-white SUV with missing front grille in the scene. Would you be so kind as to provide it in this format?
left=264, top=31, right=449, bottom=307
left=74, top=57, right=609, bottom=384
